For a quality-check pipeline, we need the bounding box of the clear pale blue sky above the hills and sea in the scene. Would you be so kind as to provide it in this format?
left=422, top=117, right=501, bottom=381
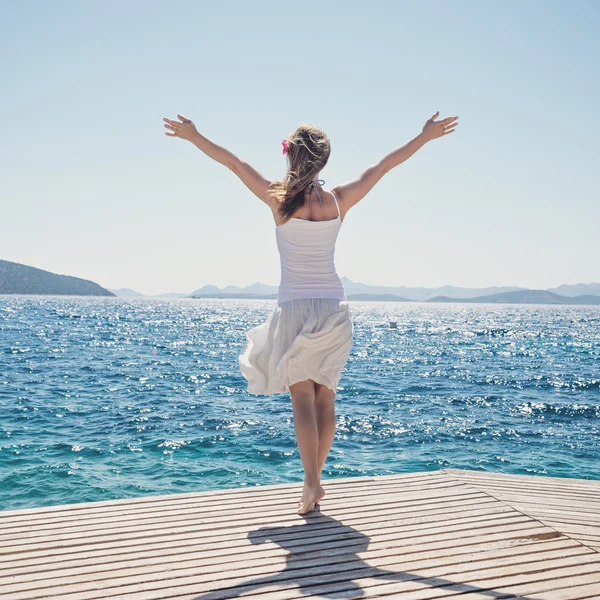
left=0, top=0, right=600, bottom=294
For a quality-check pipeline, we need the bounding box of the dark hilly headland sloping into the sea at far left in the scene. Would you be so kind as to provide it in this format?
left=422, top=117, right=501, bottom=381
left=0, top=260, right=115, bottom=296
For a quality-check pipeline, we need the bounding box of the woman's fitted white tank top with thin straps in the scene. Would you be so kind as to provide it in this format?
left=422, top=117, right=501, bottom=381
left=275, top=191, right=347, bottom=304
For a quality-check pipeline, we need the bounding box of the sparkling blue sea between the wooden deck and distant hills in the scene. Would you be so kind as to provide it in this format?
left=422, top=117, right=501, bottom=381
left=0, top=296, right=600, bottom=509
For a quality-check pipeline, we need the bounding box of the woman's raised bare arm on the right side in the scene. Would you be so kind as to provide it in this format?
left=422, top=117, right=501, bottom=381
left=334, top=112, right=458, bottom=213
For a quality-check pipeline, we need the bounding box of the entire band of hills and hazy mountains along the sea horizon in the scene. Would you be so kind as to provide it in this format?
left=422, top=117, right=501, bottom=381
left=0, top=260, right=600, bottom=304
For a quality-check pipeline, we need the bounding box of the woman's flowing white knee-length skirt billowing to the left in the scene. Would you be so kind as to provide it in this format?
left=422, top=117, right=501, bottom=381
left=238, top=298, right=354, bottom=394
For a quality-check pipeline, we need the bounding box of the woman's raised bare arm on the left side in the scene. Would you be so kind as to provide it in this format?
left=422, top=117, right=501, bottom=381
left=163, top=115, right=273, bottom=204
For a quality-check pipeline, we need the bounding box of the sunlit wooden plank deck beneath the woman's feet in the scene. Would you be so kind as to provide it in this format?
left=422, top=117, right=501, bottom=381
left=0, top=469, right=600, bottom=600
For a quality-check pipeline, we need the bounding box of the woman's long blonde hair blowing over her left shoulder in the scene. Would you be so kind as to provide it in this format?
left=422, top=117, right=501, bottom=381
left=272, top=123, right=331, bottom=222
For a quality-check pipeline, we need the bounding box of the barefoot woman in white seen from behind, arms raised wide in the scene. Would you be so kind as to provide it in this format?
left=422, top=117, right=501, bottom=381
left=164, top=112, right=458, bottom=514
